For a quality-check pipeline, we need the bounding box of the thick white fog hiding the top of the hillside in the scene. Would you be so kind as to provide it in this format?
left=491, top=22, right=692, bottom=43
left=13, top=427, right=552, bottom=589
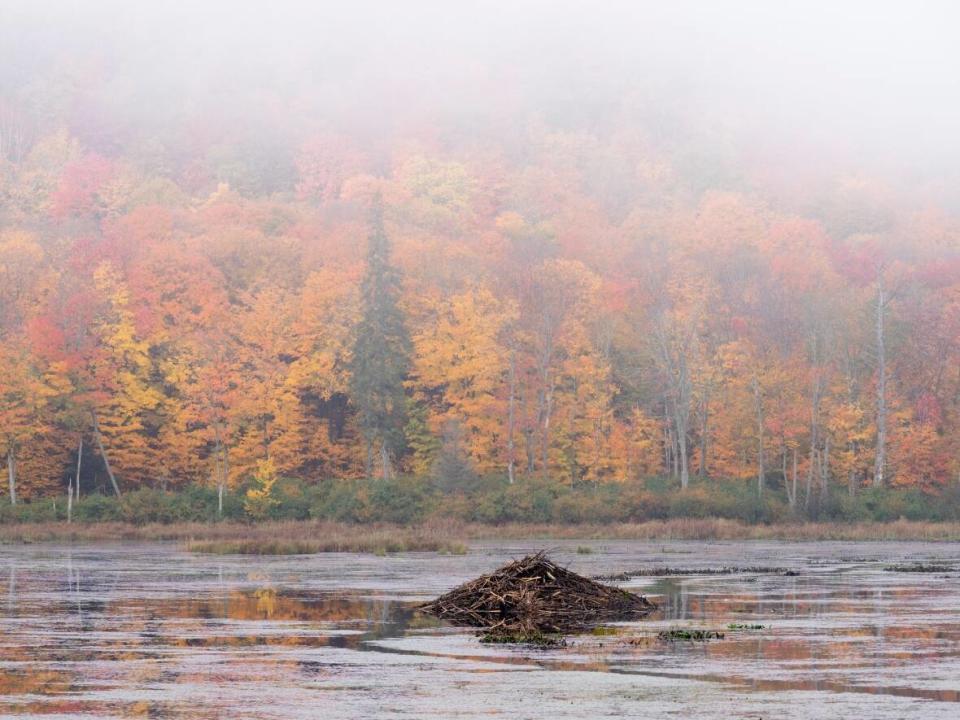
left=0, top=0, right=960, bottom=205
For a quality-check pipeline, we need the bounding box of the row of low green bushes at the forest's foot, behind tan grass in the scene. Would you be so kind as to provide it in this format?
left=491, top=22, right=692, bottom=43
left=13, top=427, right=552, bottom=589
left=0, top=475, right=960, bottom=524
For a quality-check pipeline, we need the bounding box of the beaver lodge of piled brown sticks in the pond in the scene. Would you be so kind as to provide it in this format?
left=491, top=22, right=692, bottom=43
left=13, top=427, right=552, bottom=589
left=420, top=552, right=656, bottom=637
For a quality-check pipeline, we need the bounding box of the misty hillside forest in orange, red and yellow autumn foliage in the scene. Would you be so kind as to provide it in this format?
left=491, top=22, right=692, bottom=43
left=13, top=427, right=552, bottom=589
left=0, top=4, right=960, bottom=520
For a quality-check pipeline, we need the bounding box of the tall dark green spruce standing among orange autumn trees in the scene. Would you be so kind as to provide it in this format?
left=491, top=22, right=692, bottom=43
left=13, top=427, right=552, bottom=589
left=350, top=198, right=411, bottom=479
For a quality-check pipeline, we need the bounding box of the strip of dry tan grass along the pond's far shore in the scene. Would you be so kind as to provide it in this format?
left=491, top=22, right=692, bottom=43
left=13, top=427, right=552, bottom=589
left=0, top=518, right=960, bottom=554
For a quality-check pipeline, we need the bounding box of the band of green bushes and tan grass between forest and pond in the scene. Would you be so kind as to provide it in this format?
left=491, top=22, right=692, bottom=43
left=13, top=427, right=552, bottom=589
left=0, top=476, right=960, bottom=555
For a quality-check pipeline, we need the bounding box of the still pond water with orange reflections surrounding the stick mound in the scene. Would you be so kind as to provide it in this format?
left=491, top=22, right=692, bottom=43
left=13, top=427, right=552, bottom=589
left=0, top=541, right=960, bottom=720
